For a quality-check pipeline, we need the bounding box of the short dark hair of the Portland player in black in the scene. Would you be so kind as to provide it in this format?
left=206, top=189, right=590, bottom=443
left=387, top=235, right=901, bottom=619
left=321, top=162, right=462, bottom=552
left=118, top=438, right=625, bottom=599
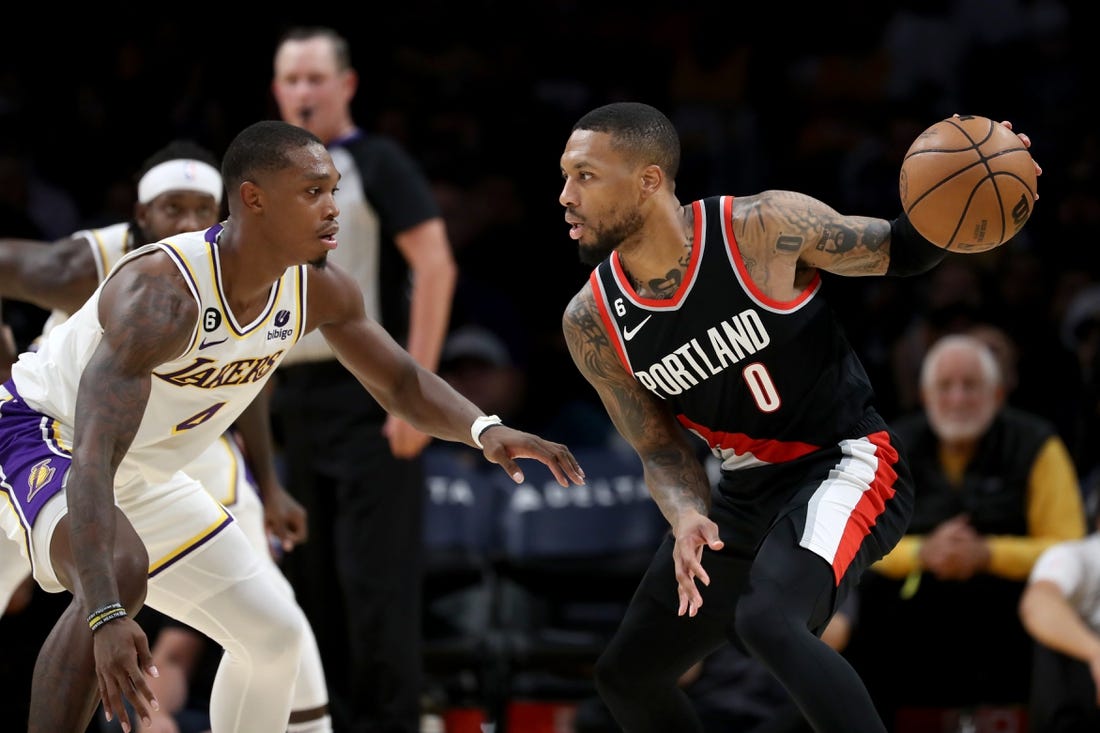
left=573, top=102, right=680, bottom=180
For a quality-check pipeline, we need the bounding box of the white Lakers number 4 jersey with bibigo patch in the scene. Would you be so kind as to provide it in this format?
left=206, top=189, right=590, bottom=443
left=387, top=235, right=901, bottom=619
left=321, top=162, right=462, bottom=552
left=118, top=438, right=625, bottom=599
left=12, top=225, right=306, bottom=485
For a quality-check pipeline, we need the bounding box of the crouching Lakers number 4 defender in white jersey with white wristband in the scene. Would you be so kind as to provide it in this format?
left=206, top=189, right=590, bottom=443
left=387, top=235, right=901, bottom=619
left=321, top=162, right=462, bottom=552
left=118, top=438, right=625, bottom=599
left=0, top=120, right=584, bottom=733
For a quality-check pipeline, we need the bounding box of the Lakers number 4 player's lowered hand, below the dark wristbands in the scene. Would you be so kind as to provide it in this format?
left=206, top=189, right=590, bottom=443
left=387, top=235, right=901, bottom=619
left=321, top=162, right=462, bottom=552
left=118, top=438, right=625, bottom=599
left=92, top=616, right=161, bottom=733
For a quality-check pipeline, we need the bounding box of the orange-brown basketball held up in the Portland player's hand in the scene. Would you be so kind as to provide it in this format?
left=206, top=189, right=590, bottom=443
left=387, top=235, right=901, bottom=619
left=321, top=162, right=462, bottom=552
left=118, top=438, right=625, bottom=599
left=899, top=116, right=1036, bottom=252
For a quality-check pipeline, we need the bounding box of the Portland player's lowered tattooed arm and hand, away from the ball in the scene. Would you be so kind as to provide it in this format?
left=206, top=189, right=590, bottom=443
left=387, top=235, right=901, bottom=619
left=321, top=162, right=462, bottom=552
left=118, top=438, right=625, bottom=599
left=562, top=284, right=722, bottom=616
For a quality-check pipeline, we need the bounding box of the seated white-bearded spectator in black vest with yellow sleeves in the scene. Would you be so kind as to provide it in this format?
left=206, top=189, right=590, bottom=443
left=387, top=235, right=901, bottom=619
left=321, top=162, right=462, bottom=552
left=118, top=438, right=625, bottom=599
left=854, top=333, right=1086, bottom=723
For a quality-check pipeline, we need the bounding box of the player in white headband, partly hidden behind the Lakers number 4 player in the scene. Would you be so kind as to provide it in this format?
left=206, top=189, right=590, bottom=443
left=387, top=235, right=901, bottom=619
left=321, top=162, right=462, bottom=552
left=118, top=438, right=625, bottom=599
left=0, top=140, right=332, bottom=733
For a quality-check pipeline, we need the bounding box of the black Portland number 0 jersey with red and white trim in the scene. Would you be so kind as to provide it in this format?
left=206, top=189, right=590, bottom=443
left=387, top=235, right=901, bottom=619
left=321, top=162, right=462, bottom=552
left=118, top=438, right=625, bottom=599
left=591, top=196, right=883, bottom=470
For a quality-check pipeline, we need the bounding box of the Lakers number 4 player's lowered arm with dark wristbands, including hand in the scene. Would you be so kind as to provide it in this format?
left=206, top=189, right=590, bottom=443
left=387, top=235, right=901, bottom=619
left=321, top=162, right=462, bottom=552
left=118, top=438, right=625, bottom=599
left=67, top=253, right=198, bottom=721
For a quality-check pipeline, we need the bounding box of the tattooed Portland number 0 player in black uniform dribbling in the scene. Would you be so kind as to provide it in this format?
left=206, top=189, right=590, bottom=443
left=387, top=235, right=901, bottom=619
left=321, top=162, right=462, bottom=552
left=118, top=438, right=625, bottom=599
left=560, top=102, right=1038, bottom=733
